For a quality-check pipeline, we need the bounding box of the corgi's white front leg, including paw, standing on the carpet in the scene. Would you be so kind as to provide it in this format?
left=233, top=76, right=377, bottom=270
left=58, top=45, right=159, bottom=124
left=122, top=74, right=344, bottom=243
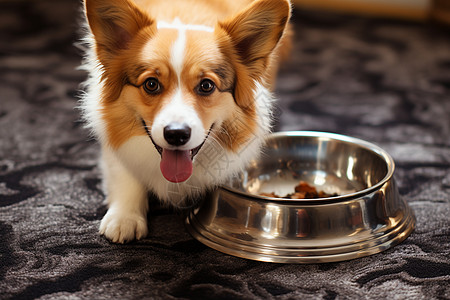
left=100, top=147, right=148, bottom=243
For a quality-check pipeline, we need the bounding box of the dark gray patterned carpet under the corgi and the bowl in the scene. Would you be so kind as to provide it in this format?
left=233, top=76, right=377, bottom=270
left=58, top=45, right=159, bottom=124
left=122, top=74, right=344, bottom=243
left=0, top=0, right=450, bottom=299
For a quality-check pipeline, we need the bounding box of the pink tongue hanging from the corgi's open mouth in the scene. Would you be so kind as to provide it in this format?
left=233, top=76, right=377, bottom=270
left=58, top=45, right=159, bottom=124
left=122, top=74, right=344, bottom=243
left=159, top=149, right=192, bottom=183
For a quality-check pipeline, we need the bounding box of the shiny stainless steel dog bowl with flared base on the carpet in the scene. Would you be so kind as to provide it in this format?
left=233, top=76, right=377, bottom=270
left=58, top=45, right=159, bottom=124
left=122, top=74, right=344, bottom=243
left=186, top=131, right=415, bottom=263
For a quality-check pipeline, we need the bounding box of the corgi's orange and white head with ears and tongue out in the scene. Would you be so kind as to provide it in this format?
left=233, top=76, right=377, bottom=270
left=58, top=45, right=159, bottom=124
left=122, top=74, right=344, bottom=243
left=86, top=0, right=290, bottom=182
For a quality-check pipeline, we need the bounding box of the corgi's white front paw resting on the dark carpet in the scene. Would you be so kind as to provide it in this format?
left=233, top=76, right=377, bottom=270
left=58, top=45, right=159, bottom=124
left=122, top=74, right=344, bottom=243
left=100, top=209, right=148, bottom=244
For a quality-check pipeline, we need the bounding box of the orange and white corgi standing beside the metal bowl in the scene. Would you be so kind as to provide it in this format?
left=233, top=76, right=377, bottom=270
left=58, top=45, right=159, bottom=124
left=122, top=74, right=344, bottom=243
left=81, top=0, right=291, bottom=243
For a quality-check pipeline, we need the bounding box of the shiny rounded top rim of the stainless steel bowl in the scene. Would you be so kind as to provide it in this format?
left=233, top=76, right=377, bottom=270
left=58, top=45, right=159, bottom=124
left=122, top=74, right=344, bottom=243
left=220, top=130, right=395, bottom=204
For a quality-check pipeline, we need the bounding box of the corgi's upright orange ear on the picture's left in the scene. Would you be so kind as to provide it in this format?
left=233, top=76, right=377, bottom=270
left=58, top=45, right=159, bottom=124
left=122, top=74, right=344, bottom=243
left=85, top=0, right=153, bottom=55
